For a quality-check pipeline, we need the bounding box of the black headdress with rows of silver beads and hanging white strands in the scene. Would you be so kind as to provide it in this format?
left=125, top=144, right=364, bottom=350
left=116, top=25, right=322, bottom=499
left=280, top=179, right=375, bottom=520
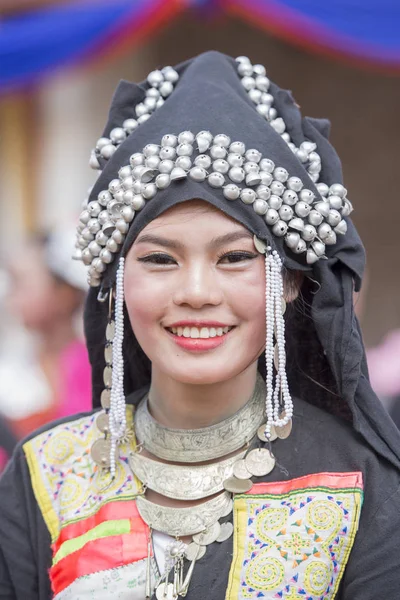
left=76, top=52, right=400, bottom=478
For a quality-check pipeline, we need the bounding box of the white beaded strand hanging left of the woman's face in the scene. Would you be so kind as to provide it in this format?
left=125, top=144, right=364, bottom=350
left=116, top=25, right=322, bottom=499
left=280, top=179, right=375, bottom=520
left=109, top=257, right=126, bottom=478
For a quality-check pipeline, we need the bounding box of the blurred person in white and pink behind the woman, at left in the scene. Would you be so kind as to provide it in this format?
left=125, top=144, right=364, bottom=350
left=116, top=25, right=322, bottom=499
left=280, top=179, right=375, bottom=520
left=0, top=228, right=91, bottom=438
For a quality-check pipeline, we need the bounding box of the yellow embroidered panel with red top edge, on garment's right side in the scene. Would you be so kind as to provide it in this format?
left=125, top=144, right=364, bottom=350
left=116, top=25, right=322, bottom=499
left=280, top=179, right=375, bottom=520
left=226, top=473, right=362, bottom=600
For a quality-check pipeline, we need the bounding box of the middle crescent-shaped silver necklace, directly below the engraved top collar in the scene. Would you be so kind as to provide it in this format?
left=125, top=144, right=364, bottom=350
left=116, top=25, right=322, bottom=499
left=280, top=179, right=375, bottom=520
left=129, top=449, right=247, bottom=500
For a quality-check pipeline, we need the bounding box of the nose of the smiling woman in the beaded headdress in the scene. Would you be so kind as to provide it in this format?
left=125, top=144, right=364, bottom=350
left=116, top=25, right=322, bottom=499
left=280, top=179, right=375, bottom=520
left=174, top=264, right=222, bottom=309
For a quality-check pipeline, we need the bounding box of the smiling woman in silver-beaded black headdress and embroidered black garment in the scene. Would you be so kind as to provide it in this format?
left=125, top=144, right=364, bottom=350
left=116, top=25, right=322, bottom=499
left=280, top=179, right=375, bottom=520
left=0, top=52, right=400, bottom=600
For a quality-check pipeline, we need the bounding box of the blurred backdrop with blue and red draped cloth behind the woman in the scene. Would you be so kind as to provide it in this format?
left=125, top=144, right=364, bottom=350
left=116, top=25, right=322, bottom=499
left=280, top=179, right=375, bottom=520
left=0, top=0, right=400, bottom=462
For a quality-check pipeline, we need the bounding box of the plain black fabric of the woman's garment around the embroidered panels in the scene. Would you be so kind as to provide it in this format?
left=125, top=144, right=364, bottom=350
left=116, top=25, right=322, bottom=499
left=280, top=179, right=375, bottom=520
left=0, top=398, right=400, bottom=600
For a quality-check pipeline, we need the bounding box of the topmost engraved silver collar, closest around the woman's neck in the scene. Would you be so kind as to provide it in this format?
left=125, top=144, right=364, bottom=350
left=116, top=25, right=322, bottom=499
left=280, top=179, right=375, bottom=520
left=135, top=375, right=265, bottom=463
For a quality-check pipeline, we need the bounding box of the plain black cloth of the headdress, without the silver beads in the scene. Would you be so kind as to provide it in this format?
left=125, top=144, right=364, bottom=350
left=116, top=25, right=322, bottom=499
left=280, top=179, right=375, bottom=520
left=85, top=52, right=400, bottom=467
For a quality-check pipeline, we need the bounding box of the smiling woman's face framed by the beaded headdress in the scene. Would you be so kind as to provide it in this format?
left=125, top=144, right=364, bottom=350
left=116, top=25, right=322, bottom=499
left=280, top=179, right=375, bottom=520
left=125, top=201, right=265, bottom=384
